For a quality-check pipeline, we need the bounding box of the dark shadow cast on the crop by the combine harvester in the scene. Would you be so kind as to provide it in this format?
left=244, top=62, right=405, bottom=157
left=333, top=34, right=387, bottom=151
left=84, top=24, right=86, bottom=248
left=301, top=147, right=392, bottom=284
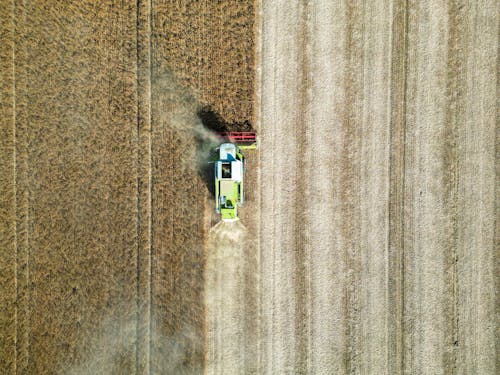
left=195, top=106, right=255, bottom=198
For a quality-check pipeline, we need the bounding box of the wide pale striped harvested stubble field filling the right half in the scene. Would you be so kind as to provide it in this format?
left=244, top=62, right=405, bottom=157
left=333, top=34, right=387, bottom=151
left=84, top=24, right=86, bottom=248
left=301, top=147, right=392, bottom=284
left=259, top=0, right=498, bottom=374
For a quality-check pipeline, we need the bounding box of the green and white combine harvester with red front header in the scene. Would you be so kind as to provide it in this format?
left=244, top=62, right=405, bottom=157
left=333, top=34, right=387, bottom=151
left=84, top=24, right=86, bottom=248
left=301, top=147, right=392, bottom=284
left=214, top=132, right=257, bottom=222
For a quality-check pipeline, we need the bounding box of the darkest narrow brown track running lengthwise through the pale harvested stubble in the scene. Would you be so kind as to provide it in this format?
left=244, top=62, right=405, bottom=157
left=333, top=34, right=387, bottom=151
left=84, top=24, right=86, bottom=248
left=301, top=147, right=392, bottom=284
left=386, top=0, right=408, bottom=373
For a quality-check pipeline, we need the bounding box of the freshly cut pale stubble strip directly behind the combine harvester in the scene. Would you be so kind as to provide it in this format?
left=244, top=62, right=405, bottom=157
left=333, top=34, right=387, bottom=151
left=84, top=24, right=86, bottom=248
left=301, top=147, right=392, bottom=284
left=205, top=221, right=247, bottom=374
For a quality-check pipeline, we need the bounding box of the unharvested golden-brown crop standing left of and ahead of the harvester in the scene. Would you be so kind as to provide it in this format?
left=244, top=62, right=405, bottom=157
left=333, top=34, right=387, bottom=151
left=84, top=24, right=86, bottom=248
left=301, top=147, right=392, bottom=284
left=0, top=0, right=254, bottom=374
